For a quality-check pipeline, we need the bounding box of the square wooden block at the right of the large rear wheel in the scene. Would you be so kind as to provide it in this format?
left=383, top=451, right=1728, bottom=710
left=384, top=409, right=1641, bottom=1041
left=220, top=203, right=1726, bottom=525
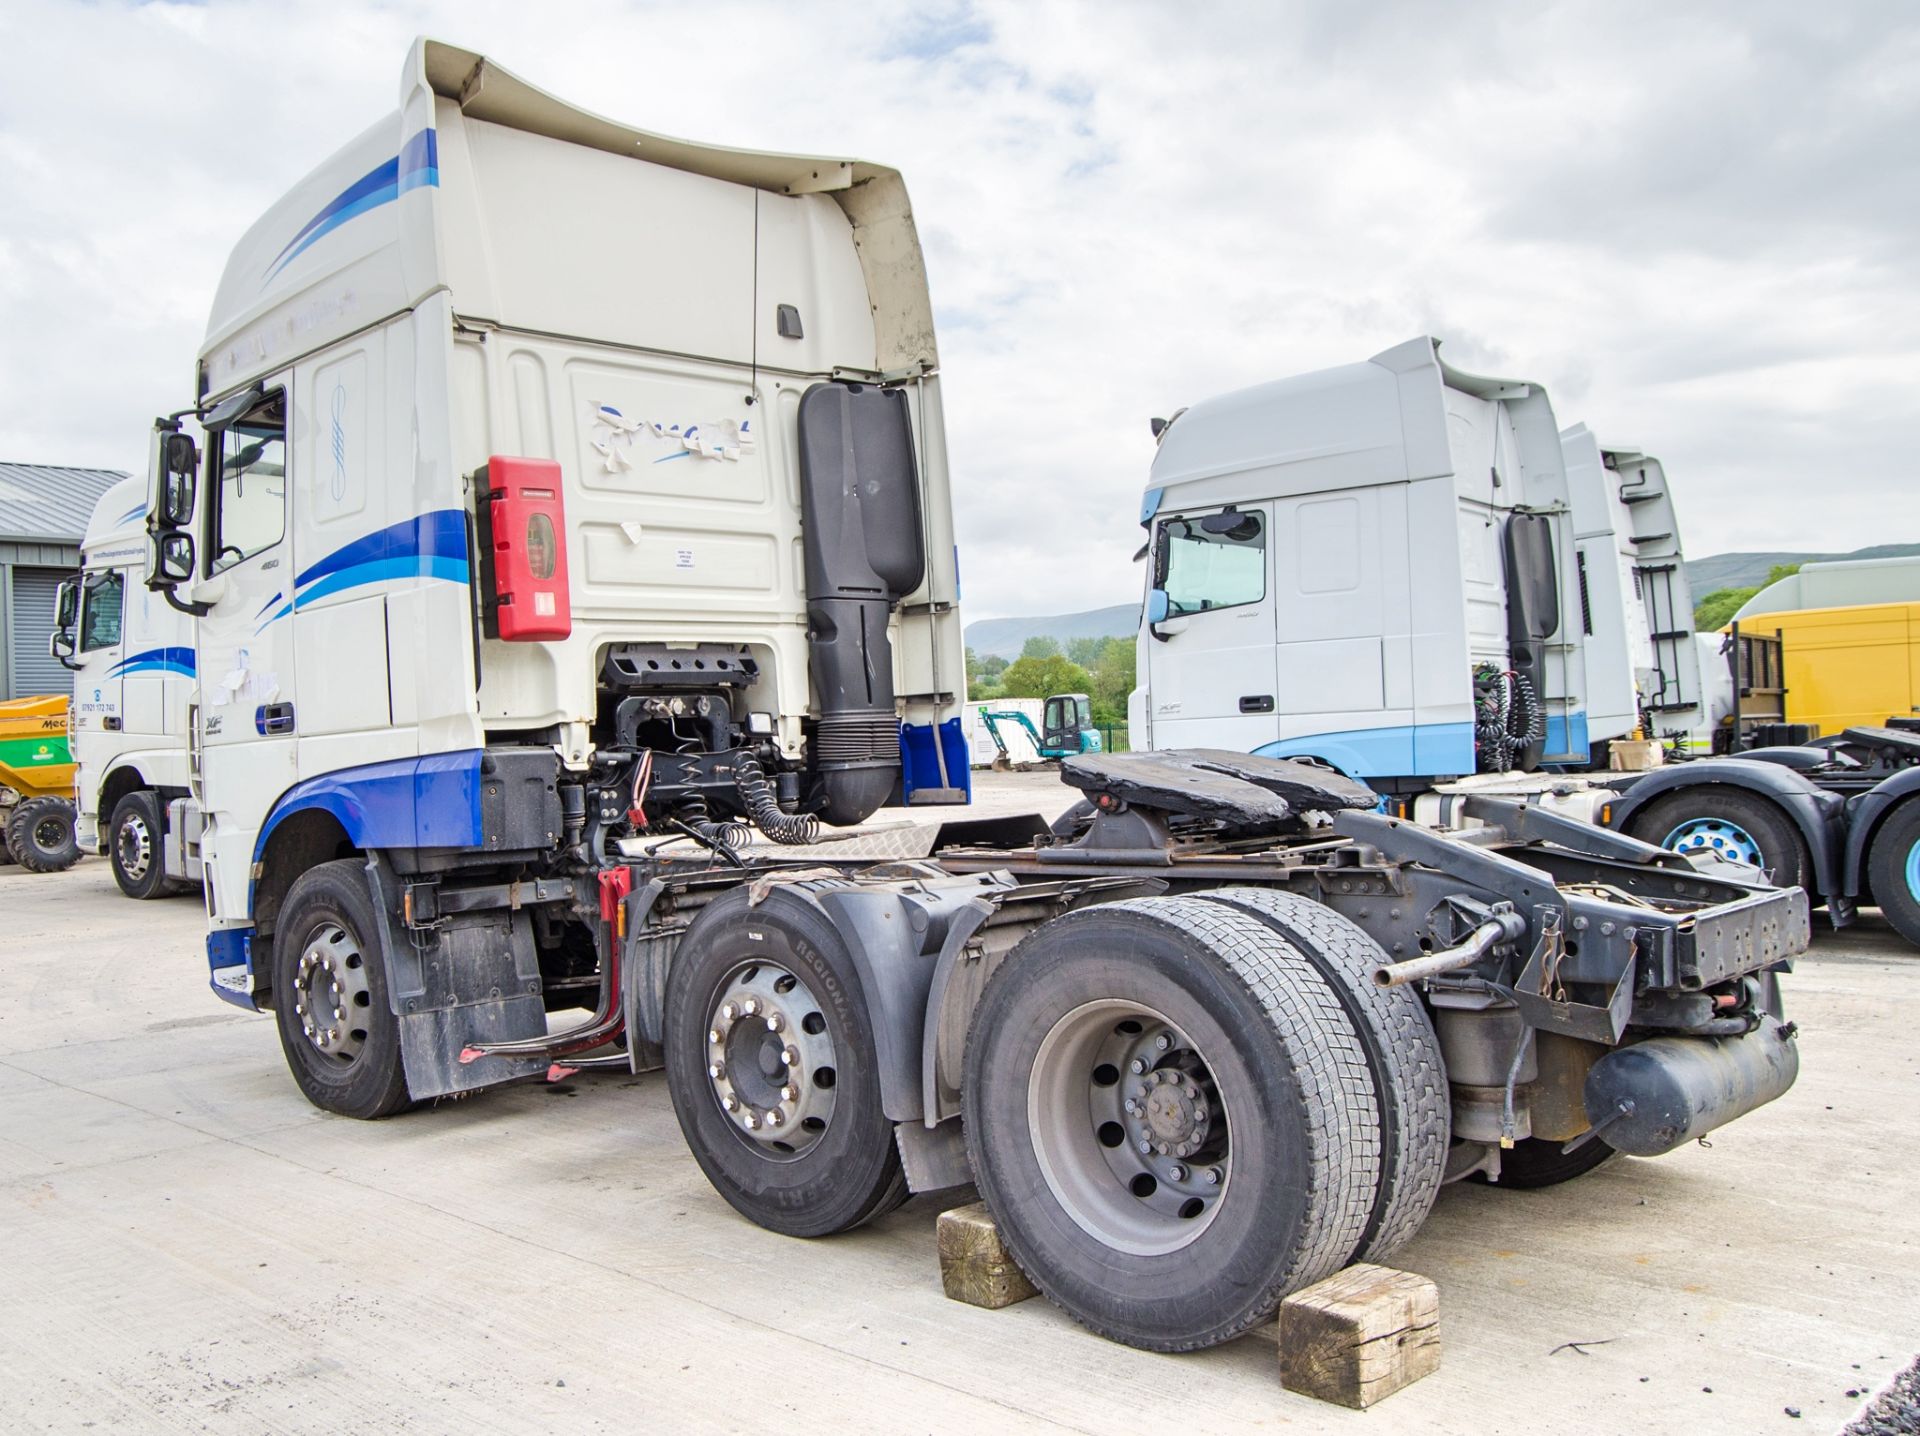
left=1279, top=1261, right=1440, bottom=1409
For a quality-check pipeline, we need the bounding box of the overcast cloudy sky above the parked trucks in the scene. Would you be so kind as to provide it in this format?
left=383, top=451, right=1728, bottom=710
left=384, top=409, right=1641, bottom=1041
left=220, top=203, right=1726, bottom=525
left=0, top=0, right=1920, bottom=618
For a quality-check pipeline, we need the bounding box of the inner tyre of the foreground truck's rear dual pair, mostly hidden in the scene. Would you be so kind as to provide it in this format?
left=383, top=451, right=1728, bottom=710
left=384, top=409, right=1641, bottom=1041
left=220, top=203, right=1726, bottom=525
left=1200, top=887, right=1453, bottom=1261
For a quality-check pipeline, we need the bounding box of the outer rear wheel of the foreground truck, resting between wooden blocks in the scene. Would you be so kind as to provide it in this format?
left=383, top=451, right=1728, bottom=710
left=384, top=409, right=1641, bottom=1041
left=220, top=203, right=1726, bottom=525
left=964, top=897, right=1380, bottom=1352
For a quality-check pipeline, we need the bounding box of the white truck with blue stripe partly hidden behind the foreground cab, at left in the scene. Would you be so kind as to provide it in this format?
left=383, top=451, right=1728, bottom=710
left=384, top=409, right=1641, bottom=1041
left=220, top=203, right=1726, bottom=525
left=54, top=478, right=200, bottom=898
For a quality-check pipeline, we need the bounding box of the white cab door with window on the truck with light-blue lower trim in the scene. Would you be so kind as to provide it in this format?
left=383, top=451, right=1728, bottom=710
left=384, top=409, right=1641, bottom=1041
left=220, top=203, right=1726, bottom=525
left=1146, top=503, right=1281, bottom=753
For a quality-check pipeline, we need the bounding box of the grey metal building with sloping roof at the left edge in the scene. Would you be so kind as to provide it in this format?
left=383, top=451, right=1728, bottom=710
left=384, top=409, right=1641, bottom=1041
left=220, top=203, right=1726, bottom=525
left=0, top=463, right=127, bottom=699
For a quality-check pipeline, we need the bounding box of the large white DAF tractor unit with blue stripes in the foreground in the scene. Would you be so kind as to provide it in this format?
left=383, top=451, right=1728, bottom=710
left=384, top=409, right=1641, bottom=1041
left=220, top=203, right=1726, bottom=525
left=150, top=40, right=1807, bottom=1350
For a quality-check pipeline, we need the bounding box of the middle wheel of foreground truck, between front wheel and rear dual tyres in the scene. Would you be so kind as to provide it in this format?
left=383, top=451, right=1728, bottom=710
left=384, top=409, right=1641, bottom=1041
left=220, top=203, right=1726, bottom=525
left=664, top=887, right=906, bottom=1236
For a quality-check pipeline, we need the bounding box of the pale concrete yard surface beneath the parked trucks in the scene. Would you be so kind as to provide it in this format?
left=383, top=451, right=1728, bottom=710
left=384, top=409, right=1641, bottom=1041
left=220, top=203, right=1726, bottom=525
left=0, top=776, right=1920, bottom=1436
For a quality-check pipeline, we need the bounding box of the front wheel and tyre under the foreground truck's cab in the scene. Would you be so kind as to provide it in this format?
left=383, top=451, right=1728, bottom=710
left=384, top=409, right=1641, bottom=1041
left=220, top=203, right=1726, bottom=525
left=273, top=858, right=409, bottom=1119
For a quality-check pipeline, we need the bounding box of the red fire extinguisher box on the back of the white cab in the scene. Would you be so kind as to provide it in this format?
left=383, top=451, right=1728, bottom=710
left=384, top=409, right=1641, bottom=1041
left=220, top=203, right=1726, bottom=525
left=476, top=455, right=574, bottom=643
